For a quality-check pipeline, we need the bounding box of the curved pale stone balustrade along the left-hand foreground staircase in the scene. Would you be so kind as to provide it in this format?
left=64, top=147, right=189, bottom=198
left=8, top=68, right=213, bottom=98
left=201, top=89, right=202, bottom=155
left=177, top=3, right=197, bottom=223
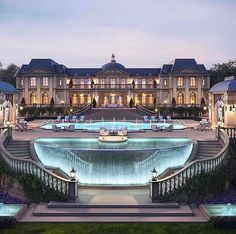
left=0, top=128, right=77, bottom=200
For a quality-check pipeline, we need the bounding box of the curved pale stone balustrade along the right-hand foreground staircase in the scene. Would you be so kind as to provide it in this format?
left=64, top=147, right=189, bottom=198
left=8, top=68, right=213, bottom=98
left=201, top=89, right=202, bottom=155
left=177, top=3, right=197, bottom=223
left=149, top=130, right=229, bottom=201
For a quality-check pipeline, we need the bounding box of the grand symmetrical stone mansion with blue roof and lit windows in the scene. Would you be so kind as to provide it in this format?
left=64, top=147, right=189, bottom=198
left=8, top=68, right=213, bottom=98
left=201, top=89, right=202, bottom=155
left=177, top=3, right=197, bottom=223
left=16, top=54, right=210, bottom=107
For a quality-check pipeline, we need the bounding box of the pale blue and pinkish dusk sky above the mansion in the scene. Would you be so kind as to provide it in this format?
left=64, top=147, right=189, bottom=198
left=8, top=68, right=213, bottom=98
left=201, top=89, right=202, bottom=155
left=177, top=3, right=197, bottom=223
left=0, top=0, right=236, bottom=68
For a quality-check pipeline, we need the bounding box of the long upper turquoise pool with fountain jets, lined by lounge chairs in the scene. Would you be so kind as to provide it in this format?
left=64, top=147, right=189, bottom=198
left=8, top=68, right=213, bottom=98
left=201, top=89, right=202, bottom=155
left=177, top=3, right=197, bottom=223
left=41, top=121, right=186, bottom=131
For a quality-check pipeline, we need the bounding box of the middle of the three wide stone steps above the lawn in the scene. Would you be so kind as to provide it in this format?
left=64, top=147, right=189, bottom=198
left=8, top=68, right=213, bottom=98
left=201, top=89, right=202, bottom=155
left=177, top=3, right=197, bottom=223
left=33, top=204, right=194, bottom=217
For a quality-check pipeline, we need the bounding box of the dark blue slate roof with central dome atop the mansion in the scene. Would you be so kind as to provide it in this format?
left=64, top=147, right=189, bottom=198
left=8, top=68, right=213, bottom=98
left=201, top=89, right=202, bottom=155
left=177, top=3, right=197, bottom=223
left=18, top=55, right=207, bottom=76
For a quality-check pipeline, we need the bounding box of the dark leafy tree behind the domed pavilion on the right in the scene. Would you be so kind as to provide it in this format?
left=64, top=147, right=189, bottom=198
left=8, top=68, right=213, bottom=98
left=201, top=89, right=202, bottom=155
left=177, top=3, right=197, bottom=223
left=209, top=60, right=236, bottom=86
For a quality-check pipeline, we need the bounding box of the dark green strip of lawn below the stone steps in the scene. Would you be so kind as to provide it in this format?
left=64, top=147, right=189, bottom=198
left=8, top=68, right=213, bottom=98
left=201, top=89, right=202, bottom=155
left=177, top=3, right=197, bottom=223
left=0, top=223, right=236, bottom=234
